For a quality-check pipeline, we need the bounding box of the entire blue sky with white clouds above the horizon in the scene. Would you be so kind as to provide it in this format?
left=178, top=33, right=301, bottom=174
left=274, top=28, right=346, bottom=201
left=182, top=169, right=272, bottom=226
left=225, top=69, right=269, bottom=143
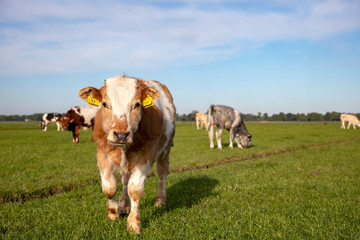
left=0, top=0, right=360, bottom=115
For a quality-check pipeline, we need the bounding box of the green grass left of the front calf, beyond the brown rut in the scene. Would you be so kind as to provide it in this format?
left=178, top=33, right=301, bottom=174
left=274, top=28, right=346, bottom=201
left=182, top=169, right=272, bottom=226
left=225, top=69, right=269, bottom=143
left=0, top=122, right=99, bottom=197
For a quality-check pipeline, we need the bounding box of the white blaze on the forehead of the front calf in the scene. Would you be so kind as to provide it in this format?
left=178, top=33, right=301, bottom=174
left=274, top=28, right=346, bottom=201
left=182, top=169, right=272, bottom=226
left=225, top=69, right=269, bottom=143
left=106, top=76, right=136, bottom=119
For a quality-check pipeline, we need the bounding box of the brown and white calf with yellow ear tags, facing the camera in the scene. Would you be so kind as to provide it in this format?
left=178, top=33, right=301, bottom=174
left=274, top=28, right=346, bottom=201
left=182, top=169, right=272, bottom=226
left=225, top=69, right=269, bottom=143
left=79, top=75, right=176, bottom=234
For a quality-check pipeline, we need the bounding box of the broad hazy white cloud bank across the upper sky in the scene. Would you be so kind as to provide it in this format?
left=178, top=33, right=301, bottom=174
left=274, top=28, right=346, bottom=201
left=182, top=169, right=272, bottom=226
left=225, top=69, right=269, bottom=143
left=0, top=0, right=360, bottom=75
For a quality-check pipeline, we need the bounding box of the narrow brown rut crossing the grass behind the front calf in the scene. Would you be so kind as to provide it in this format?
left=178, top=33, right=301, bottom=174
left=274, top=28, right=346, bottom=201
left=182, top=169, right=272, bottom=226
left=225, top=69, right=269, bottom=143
left=0, top=138, right=359, bottom=204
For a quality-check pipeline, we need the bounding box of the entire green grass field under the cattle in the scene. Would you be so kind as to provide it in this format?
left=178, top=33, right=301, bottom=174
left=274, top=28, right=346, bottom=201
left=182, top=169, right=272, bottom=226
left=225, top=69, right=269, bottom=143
left=0, top=122, right=360, bottom=239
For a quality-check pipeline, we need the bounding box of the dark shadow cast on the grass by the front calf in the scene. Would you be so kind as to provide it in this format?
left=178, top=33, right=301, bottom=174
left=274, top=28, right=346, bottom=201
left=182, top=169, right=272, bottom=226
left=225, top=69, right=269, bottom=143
left=142, top=176, right=219, bottom=227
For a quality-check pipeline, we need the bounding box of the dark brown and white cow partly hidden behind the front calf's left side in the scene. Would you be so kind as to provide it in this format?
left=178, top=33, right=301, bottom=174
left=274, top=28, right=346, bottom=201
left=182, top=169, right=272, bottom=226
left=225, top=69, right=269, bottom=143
left=60, top=106, right=98, bottom=143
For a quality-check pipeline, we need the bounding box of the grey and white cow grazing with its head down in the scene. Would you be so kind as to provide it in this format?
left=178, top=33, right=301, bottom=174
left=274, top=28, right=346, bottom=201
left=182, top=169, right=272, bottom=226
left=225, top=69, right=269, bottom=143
left=206, top=105, right=252, bottom=149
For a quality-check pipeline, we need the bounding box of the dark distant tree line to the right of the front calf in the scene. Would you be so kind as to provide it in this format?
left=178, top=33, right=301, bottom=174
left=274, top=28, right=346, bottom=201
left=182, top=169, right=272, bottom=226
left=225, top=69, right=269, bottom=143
left=176, top=110, right=360, bottom=122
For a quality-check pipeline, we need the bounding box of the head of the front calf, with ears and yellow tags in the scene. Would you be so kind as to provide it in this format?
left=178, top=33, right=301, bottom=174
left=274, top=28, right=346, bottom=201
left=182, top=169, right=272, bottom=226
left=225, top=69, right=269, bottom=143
left=78, top=76, right=160, bottom=147
